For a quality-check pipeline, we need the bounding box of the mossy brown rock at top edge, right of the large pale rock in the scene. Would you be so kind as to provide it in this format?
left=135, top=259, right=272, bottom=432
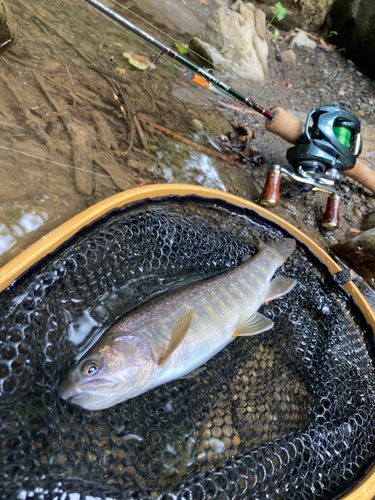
left=247, top=0, right=334, bottom=31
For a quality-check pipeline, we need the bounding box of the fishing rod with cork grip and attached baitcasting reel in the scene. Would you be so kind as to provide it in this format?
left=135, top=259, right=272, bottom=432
left=83, top=0, right=375, bottom=229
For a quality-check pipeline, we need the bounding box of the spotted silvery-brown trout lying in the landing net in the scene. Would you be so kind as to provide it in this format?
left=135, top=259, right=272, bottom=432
left=59, top=238, right=296, bottom=410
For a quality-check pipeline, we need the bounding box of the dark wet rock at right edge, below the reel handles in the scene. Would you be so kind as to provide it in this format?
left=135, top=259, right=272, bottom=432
left=330, top=229, right=375, bottom=286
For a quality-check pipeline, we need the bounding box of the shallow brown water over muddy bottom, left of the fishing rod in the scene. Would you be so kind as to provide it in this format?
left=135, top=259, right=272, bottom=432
left=0, top=0, right=266, bottom=266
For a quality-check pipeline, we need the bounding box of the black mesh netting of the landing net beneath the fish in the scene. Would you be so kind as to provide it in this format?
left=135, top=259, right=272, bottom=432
left=0, top=198, right=375, bottom=500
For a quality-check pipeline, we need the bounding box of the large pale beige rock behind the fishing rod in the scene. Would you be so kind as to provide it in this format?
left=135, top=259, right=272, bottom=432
left=190, top=0, right=268, bottom=82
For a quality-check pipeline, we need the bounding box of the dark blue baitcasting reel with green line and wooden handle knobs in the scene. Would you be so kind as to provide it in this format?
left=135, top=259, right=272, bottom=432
left=260, top=105, right=362, bottom=229
